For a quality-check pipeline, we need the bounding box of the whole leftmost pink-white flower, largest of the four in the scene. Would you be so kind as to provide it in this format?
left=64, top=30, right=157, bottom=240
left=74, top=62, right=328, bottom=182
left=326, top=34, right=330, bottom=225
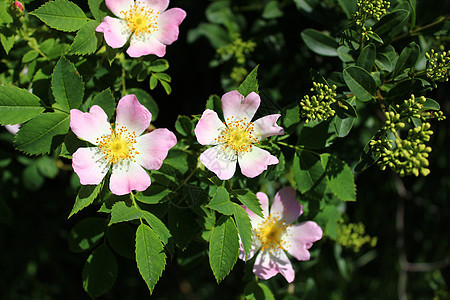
left=70, top=95, right=177, bottom=195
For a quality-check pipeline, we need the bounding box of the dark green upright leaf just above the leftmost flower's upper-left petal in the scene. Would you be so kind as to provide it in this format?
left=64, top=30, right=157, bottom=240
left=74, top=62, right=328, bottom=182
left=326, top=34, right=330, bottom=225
left=52, top=57, right=84, bottom=112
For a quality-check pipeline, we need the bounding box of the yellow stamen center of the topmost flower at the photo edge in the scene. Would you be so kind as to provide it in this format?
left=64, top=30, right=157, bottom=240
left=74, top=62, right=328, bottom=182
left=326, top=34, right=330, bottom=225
left=121, top=1, right=159, bottom=35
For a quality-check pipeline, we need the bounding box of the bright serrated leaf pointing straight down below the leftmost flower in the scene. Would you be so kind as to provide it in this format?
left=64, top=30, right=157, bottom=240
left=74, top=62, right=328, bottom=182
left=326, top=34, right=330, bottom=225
left=136, top=224, right=166, bottom=294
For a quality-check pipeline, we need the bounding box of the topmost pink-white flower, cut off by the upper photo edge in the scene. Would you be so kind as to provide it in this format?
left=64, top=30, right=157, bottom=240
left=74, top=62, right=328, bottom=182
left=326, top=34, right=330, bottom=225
left=96, top=0, right=186, bottom=57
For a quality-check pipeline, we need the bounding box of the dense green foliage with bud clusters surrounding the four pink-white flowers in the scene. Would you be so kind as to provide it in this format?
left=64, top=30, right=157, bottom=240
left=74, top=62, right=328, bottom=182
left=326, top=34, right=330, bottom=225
left=0, top=0, right=450, bottom=300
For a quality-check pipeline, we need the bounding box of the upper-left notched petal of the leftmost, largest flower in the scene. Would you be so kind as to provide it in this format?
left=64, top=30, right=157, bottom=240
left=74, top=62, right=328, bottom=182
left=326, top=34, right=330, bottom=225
left=70, top=105, right=111, bottom=145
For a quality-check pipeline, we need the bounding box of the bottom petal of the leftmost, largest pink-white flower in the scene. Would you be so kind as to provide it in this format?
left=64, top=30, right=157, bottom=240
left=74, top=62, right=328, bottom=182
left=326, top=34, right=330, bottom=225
left=109, top=160, right=151, bottom=196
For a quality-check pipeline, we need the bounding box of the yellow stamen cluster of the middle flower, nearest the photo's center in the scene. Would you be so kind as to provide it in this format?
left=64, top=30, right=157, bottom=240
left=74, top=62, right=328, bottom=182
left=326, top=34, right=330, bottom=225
left=215, top=117, right=259, bottom=155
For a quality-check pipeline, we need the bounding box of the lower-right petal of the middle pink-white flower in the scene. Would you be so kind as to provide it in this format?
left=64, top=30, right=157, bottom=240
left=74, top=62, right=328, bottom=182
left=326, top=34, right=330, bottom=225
left=238, top=146, right=278, bottom=178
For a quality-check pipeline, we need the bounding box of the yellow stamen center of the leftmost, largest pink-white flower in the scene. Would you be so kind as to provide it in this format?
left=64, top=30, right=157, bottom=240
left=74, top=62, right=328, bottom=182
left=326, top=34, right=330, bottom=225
left=97, top=127, right=139, bottom=164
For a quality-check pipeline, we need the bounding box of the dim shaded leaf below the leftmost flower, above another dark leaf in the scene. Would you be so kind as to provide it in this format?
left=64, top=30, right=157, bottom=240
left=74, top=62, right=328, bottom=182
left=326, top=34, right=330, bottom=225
left=68, top=217, right=107, bottom=253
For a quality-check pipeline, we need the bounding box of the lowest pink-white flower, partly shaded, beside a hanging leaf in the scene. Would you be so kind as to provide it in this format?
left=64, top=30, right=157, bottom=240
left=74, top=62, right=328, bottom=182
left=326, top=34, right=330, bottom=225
left=239, top=187, right=322, bottom=282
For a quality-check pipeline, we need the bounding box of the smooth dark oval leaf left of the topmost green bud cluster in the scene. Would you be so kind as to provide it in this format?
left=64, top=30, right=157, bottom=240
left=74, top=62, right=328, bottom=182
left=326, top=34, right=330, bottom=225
left=301, top=28, right=339, bottom=56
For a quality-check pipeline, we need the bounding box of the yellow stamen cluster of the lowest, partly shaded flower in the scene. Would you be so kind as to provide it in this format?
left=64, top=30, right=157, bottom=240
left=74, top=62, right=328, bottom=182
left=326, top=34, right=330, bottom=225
left=255, top=213, right=292, bottom=252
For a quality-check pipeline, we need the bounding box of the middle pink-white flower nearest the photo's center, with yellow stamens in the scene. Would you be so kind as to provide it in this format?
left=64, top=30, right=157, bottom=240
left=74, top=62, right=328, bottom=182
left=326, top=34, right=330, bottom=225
left=195, top=91, right=284, bottom=180
